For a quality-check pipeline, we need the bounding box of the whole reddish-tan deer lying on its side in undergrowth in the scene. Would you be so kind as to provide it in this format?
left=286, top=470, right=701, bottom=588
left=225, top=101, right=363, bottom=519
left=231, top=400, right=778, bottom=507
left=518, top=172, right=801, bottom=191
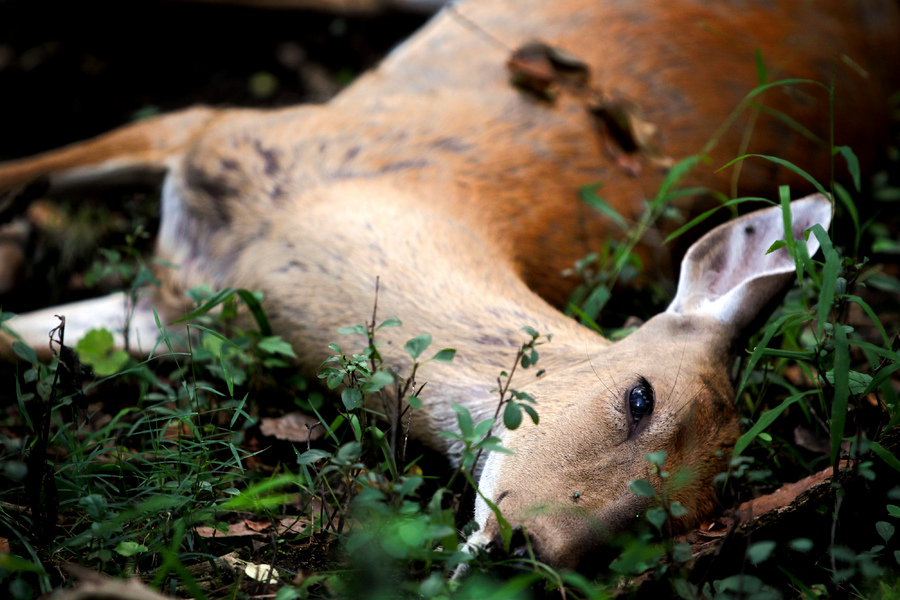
left=0, top=0, right=900, bottom=569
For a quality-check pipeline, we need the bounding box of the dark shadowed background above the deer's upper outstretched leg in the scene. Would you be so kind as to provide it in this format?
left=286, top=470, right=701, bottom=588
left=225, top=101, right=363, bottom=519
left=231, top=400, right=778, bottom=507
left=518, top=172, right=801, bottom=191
left=0, top=0, right=426, bottom=159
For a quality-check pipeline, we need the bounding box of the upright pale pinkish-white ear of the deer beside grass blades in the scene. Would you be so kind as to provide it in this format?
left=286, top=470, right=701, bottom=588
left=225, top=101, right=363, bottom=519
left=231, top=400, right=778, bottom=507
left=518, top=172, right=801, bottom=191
left=666, top=194, right=831, bottom=335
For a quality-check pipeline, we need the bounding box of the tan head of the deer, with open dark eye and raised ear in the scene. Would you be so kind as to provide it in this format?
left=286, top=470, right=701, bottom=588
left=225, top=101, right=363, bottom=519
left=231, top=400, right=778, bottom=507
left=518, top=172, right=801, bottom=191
left=469, top=196, right=831, bottom=570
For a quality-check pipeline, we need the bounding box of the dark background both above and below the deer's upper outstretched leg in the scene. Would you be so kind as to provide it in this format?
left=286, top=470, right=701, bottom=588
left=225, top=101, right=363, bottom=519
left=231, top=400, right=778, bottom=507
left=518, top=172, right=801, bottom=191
left=0, top=0, right=427, bottom=313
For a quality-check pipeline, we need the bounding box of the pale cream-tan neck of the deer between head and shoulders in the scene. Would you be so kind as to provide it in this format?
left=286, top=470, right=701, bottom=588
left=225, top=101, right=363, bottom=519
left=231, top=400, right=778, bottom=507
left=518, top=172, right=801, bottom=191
left=222, top=182, right=609, bottom=452
